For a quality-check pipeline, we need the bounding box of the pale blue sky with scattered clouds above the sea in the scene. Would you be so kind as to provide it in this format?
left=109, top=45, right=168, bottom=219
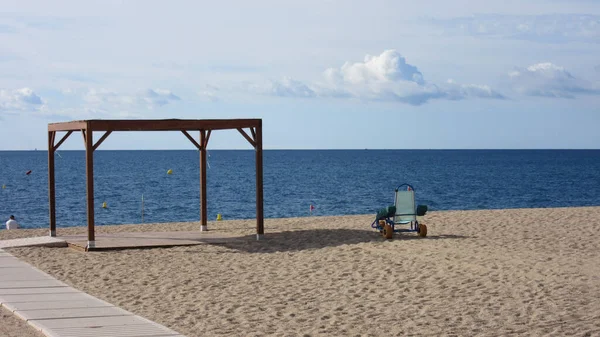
left=0, top=0, right=600, bottom=150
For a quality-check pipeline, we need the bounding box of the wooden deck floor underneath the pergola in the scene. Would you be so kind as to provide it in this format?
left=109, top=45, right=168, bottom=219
left=57, top=231, right=239, bottom=251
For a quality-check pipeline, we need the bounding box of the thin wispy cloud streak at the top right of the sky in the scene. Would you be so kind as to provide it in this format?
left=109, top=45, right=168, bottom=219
left=431, top=14, right=600, bottom=43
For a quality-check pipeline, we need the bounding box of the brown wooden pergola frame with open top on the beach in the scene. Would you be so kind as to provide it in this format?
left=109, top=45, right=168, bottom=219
left=48, top=119, right=264, bottom=248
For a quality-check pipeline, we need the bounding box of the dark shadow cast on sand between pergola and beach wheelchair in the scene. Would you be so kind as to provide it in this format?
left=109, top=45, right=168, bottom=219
left=211, top=228, right=469, bottom=253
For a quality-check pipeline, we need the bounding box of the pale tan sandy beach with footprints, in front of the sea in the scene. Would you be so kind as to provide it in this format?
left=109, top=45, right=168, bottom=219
left=0, top=207, right=600, bottom=336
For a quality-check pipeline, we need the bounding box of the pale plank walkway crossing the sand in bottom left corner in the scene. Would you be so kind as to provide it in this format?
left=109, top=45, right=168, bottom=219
left=0, top=249, right=185, bottom=337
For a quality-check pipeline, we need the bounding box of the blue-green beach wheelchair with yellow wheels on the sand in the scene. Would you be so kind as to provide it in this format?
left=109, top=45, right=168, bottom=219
left=371, top=184, right=427, bottom=239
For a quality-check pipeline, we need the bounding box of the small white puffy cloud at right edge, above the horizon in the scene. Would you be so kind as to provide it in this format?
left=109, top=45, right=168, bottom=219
left=508, top=62, right=600, bottom=98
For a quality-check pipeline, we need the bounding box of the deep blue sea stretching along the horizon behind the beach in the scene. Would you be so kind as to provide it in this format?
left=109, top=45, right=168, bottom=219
left=0, top=150, right=600, bottom=228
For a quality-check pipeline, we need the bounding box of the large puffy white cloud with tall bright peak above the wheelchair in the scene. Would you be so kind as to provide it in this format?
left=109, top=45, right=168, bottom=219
left=251, top=50, right=504, bottom=105
